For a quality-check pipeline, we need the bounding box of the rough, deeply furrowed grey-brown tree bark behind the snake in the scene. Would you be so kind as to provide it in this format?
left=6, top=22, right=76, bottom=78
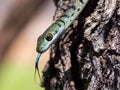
left=41, top=0, right=120, bottom=90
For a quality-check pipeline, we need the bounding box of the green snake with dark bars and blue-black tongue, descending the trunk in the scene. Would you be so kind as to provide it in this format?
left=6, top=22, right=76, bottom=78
left=35, top=0, right=89, bottom=80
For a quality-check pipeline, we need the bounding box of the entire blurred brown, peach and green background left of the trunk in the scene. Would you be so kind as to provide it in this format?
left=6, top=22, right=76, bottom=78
left=0, top=0, right=55, bottom=90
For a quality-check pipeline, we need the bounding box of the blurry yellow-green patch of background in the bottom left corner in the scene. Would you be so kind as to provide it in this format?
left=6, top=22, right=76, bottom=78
left=0, top=62, right=44, bottom=90
